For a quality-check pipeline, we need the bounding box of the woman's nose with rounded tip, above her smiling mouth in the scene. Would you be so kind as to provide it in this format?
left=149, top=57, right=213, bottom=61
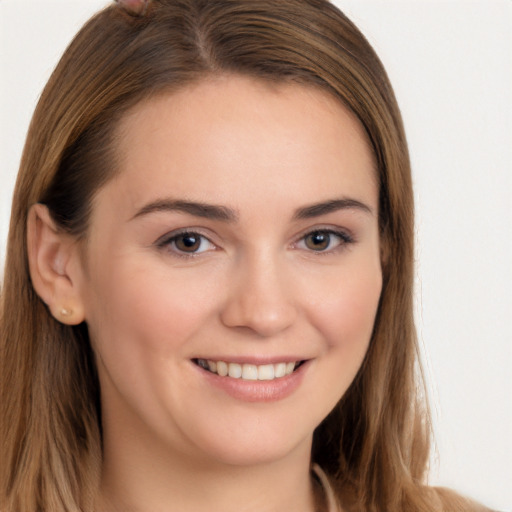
left=221, top=251, right=297, bottom=337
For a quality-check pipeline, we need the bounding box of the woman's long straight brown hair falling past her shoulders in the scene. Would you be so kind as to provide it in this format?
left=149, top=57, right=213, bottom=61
left=0, top=0, right=488, bottom=512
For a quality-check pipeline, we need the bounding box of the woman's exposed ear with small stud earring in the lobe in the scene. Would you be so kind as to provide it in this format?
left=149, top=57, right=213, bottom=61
left=27, top=204, right=84, bottom=325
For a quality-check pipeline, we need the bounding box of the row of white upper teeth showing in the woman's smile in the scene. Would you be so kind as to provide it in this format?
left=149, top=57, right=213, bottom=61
left=193, top=359, right=305, bottom=381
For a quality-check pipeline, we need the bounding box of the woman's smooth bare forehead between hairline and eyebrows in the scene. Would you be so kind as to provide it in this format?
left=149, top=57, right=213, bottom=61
left=102, top=76, right=377, bottom=217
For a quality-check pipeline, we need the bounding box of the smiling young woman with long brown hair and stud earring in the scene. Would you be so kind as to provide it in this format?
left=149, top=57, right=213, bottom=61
left=1, top=0, right=496, bottom=511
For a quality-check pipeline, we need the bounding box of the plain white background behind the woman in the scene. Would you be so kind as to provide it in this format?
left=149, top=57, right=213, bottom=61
left=0, top=0, right=512, bottom=510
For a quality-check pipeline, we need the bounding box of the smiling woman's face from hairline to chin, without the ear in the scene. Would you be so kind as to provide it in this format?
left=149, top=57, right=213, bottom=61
left=75, top=76, right=382, bottom=464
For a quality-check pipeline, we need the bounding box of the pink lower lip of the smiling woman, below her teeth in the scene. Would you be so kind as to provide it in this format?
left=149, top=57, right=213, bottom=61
left=192, top=361, right=310, bottom=402
